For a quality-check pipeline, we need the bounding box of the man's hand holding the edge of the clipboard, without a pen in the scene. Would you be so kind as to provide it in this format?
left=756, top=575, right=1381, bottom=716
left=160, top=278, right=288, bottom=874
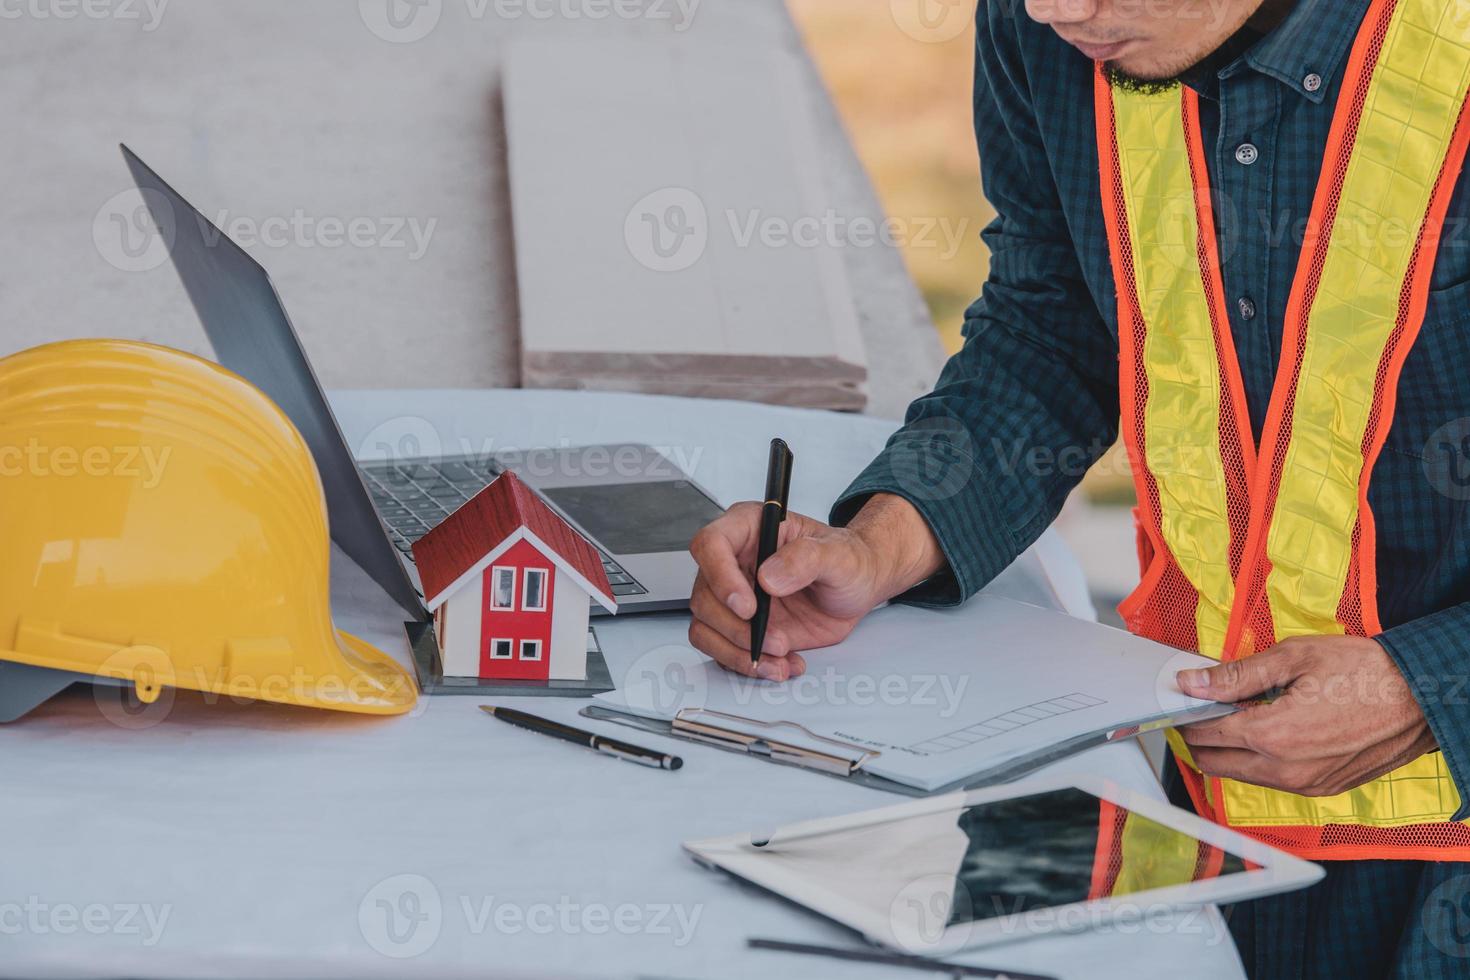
left=1179, top=636, right=1436, bottom=796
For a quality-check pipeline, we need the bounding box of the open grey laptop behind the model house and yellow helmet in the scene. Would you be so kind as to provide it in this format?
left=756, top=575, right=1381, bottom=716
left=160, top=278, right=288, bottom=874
left=122, top=145, right=723, bottom=620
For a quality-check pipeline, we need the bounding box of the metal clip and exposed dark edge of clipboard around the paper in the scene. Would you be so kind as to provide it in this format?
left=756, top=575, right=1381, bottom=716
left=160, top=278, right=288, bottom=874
left=579, top=704, right=1239, bottom=798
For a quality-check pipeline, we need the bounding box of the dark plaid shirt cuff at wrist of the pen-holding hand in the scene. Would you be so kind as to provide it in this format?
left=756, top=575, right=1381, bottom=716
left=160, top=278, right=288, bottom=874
left=829, top=430, right=1019, bottom=607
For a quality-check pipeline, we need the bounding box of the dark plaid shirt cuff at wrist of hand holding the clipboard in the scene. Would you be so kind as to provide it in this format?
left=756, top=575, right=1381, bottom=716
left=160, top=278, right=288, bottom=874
left=1374, top=604, right=1470, bottom=820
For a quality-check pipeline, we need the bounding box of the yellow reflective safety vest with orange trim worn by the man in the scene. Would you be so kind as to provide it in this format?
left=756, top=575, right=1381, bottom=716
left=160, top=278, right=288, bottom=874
left=1095, top=0, right=1470, bottom=861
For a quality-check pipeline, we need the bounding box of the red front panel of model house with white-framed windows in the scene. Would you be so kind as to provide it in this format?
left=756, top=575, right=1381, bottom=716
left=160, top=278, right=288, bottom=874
left=479, top=541, right=556, bottom=680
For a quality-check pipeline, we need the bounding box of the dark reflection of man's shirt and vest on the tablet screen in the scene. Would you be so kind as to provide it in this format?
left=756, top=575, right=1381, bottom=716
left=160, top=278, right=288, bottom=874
left=950, top=788, right=1248, bottom=926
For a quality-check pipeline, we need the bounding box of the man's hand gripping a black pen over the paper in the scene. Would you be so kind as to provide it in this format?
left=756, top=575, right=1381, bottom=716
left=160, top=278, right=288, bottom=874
left=689, top=494, right=944, bottom=680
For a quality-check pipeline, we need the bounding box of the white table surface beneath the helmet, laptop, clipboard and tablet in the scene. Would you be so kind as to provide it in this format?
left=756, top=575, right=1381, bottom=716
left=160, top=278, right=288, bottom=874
left=0, top=391, right=1242, bottom=980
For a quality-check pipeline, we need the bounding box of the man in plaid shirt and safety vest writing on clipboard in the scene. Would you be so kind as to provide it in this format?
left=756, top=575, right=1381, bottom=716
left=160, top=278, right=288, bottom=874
left=689, top=0, right=1470, bottom=977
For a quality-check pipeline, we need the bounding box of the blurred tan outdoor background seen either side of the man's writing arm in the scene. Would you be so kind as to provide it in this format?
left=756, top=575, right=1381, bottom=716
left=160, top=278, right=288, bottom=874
left=786, top=0, right=1138, bottom=623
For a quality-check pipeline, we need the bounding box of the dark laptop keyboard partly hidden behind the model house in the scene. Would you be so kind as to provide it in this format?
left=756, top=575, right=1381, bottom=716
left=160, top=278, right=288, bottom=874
left=357, top=458, right=648, bottom=598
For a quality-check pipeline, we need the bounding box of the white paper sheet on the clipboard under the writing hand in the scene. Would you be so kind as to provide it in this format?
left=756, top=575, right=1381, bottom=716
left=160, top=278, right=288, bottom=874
left=598, top=595, right=1213, bottom=790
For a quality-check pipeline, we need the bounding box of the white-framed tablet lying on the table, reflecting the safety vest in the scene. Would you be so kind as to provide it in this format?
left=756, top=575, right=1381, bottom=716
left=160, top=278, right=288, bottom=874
left=684, top=776, right=1323, bottom=955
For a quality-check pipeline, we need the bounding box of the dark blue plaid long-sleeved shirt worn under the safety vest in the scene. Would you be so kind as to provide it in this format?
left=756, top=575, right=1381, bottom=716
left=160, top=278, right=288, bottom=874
left=832, top=0, right=1470, bottom=976
